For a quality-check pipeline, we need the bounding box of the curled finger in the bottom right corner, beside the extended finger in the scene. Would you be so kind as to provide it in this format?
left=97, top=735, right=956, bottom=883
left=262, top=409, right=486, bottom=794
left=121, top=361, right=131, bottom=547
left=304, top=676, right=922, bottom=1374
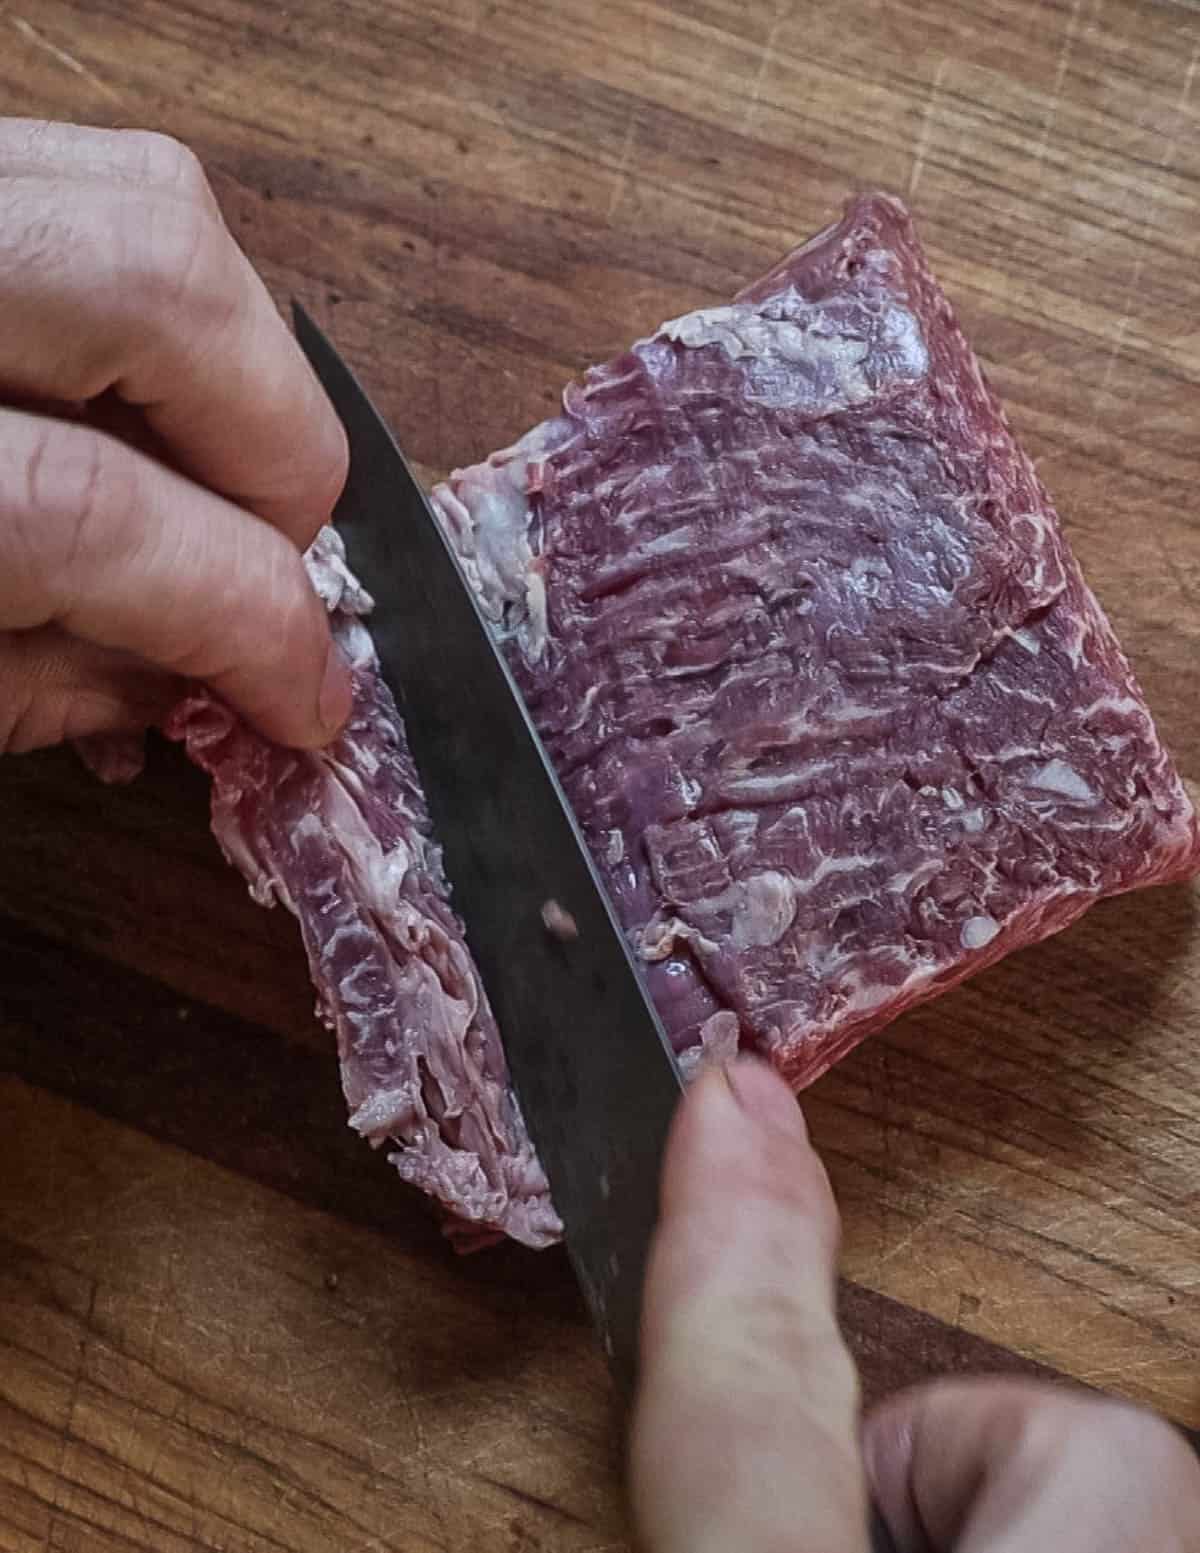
left=863, top=1378, right=1200, bottom=1553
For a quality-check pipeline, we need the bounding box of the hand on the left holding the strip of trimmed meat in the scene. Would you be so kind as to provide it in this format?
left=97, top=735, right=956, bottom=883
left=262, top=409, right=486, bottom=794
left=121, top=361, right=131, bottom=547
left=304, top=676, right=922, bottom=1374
left=0, top=120, right=351, bottom=752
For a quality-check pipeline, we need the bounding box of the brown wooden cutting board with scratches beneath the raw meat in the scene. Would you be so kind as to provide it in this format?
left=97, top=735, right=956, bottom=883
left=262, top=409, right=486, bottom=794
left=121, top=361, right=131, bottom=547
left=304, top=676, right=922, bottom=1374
left=0, top=0, right=1200, bottom=1553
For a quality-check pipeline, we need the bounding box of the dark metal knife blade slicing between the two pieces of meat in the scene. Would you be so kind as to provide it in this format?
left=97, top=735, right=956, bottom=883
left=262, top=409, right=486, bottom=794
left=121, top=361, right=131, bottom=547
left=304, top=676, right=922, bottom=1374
left=293, top=304, right=680, bottom=1382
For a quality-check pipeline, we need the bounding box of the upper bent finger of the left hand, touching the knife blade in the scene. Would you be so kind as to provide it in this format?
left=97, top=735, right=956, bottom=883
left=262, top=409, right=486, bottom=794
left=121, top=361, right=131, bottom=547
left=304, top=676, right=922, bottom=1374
left=0, top=143, right=346, bottom=548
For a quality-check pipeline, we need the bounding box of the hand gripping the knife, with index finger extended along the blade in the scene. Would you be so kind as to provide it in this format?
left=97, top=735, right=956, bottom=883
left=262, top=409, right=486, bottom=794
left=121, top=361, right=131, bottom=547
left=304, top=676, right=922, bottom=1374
left=630, top=1059, right=1200, bottom=1553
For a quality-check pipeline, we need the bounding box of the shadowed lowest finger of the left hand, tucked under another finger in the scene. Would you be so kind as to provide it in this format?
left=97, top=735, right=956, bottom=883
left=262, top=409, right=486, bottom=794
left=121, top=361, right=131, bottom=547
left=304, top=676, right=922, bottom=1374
left=0, top=626, right=185, bottom=755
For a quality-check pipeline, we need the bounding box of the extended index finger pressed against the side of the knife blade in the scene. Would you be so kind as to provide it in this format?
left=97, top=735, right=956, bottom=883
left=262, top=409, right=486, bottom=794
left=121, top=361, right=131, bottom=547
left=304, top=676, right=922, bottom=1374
left=630, top=1059, right=866, bottom=1553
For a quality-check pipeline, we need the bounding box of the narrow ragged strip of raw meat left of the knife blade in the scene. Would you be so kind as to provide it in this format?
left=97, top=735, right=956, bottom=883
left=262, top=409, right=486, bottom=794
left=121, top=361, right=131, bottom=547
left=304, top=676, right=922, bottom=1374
left=166, top=528, right=560, bottom=1249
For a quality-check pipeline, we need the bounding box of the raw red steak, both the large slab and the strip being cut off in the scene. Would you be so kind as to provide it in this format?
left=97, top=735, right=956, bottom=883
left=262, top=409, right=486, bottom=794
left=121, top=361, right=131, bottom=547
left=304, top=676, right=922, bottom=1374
left=93, top=196, right=1200, bottom=1246
